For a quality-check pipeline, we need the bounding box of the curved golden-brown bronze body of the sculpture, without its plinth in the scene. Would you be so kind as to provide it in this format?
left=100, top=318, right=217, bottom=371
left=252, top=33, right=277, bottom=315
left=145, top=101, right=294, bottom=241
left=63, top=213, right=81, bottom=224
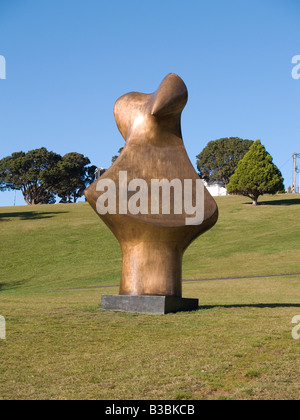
left=85, top=73, right=218, bottom=297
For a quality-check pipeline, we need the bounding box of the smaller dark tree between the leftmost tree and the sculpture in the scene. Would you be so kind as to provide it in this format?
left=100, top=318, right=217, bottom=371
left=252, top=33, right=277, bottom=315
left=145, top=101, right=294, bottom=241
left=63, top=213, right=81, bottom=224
left=52, top=152, right=96, bottom=203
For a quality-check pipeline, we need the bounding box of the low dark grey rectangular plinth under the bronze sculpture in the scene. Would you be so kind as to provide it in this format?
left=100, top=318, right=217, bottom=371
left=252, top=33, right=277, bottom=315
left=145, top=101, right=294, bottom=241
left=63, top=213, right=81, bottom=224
left=101, top=295, right=199, bottom=315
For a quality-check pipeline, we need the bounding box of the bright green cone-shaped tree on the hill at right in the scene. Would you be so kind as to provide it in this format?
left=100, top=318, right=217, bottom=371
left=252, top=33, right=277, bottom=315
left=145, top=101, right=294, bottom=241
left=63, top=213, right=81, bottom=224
left=227, top=140, right=284, bottom=205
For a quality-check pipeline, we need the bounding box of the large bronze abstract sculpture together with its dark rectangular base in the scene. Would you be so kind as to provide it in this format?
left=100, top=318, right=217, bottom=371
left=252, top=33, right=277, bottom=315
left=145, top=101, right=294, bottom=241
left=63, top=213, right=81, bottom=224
left=85, top=73, right=218, bottom=313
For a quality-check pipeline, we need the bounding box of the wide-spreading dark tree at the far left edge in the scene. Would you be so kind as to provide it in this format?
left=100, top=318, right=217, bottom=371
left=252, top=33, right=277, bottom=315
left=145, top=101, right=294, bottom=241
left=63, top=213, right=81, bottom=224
left=0, top=147, right=61, bottom=205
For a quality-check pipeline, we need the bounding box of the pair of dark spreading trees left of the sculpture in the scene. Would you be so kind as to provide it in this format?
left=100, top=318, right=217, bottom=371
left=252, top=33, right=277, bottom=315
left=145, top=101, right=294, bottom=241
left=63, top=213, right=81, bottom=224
left=0, top=147, right=95, bottom=205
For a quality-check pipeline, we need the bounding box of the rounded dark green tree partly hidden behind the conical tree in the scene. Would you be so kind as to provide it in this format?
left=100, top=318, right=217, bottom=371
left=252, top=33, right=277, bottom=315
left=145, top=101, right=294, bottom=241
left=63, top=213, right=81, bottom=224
left=196, top=137, right=253, bottom=185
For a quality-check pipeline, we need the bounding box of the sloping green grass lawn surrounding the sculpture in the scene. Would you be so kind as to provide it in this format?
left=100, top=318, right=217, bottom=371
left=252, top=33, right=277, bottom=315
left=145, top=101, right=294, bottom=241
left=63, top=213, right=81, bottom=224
left=0, top=195, right=300, bottom=400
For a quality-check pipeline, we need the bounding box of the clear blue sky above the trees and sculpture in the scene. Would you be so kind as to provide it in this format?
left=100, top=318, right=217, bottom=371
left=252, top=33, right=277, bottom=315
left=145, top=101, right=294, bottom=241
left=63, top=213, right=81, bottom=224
left=0, top=0, right=300, bottom=206
